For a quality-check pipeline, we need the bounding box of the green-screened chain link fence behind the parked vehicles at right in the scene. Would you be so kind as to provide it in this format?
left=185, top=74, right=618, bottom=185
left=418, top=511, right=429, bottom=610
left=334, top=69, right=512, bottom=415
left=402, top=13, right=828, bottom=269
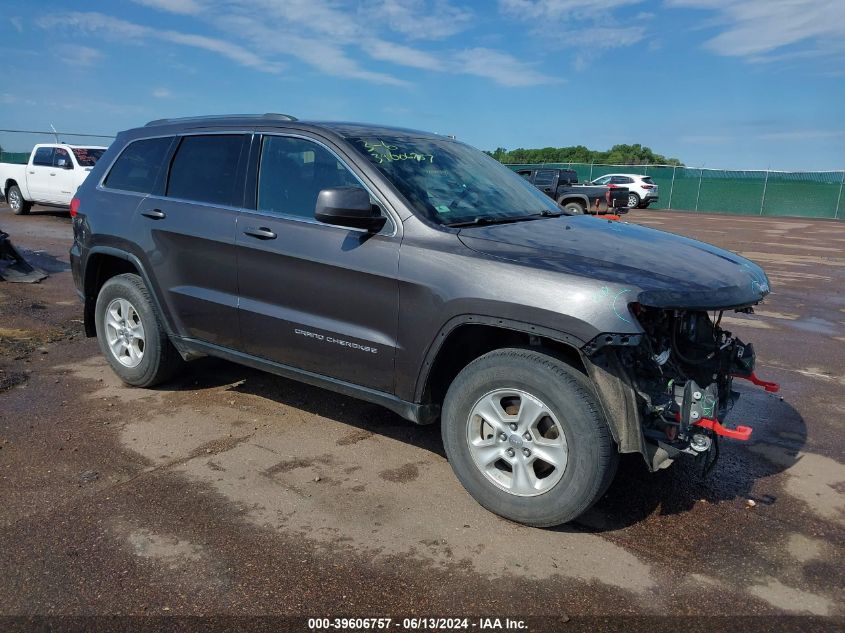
left=507, top=163, right=845, bottom=219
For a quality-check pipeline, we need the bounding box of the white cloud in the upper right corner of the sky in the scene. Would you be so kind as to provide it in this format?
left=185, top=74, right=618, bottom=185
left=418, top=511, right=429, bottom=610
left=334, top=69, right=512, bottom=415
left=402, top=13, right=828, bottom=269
left=666, top=0, right=845, bottom=62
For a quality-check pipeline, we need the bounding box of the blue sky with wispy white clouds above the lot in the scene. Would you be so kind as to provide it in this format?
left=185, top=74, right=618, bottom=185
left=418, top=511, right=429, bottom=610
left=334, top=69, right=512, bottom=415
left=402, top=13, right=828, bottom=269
left=0, top=0, right=845, bottom=170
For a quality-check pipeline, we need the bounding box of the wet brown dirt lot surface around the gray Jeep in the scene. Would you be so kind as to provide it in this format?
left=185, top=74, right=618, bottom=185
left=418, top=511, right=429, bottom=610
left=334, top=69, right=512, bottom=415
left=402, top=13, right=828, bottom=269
left=0, top=207, right=845, bottom=629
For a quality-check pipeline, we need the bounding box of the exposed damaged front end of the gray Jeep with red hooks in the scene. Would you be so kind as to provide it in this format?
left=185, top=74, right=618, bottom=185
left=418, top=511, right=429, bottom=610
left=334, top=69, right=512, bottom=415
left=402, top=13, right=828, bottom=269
left=582, top=303, right=778, bottom=472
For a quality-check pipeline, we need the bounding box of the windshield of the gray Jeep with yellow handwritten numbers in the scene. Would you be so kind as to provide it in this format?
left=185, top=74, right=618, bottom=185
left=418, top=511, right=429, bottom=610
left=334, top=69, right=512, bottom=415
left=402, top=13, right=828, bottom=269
left=347, top=136, right=561, bottom=224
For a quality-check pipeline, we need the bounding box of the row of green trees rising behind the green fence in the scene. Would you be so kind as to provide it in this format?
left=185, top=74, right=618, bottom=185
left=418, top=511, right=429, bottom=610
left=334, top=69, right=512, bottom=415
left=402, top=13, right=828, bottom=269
left=487, top=143, right=683, bottom=167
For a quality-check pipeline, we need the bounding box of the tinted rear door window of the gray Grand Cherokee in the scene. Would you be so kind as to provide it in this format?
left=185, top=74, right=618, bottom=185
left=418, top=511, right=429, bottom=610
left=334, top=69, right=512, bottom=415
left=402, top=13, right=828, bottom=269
left=167, top=134, right=244, bottom=206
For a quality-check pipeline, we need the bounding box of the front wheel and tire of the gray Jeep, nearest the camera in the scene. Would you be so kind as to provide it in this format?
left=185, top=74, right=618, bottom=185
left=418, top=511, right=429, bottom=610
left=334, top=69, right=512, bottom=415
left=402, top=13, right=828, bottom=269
left=441, top=348, right=618, bottom=527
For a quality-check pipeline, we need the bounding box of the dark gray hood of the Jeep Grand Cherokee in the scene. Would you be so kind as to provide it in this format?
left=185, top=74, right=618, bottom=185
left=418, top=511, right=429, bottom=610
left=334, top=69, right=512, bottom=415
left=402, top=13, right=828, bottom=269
left=458, top=216, right=769, bottom=310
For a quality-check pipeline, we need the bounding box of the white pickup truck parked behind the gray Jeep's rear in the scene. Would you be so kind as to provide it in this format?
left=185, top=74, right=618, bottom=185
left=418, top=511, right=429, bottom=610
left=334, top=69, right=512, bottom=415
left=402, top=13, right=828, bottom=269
left=0, top=143, right=106, bottom=215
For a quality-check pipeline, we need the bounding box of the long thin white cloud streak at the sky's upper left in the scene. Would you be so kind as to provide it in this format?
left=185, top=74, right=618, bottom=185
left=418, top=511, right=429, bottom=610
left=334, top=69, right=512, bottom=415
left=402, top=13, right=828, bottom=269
left=38, top=12, right=282, bottom=73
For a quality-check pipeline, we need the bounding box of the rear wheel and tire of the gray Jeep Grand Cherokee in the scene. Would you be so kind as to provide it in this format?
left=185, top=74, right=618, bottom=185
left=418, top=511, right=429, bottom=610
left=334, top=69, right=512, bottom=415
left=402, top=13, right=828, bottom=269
left=95, top=273, right=182, bottom=387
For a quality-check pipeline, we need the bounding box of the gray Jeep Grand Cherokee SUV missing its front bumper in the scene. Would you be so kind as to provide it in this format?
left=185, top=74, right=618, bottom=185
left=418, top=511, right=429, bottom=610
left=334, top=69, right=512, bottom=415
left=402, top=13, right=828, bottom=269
left=71, top=115, right=776, bottom=526
